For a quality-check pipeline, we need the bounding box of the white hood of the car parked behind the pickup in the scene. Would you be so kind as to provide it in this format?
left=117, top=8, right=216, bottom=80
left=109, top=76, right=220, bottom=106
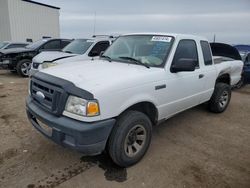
left=33, top=51, right=77, bottom=63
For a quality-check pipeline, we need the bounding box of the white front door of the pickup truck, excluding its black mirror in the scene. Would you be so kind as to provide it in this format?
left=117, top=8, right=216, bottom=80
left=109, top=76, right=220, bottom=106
left=161, top=39, right=205, bottom=118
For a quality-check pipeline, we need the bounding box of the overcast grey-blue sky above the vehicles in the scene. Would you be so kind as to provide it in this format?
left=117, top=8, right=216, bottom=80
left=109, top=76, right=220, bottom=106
left=35, top=0, right=250, bottom=44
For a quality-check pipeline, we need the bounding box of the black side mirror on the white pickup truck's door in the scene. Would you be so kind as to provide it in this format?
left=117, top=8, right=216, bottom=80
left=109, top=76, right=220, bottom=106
left=170, top=58, right=197, bottom=73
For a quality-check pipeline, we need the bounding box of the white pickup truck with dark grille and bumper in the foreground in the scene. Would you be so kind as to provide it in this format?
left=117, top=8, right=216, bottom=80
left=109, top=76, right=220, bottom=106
left=26, top=33, right=243, bottom=167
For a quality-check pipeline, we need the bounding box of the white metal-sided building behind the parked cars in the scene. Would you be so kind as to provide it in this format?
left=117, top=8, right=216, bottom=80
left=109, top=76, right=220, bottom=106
left=0, top=0, right=60, bottom=42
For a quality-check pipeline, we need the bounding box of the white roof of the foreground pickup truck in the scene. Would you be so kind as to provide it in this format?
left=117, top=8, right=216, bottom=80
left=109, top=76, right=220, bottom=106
left=121, top=32, right=207, bottom=41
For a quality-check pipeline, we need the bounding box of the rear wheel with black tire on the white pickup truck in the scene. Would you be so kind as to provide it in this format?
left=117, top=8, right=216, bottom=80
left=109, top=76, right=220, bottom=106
left=208, top=83, right=231, bottom=113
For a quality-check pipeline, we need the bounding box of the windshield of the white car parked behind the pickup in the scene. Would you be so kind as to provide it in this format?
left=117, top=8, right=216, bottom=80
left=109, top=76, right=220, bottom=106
left=62, top=39, right=94, bottom=54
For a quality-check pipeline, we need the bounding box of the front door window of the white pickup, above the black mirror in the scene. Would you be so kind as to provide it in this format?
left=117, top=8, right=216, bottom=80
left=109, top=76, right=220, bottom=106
left=173, top=39, right=199, bottom=68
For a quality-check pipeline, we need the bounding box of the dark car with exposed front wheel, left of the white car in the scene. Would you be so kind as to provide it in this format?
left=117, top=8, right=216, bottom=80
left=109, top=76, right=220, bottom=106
left=0, top=38, right=71, bottom=77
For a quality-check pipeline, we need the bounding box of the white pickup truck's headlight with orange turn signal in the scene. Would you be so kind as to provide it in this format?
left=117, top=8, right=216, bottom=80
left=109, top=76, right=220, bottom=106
left=65, top=95, right=100, bottom=117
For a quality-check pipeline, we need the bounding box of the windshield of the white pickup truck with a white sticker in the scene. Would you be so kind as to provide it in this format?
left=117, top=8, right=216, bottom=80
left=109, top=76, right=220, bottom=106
left=103, top=35, right=173, bottom=67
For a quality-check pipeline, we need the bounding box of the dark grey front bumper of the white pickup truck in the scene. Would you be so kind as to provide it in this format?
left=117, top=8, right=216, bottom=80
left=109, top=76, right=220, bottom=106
left=26, top=97, right=115, bottom=155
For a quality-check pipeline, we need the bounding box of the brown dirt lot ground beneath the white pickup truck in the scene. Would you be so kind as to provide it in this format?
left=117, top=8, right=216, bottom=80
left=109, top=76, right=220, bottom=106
left=0, top=70, right=250, bottom=188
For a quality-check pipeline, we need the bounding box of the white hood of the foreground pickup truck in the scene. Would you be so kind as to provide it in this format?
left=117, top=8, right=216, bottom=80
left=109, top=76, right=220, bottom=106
left=41, top=59, right=166, bottom=94
